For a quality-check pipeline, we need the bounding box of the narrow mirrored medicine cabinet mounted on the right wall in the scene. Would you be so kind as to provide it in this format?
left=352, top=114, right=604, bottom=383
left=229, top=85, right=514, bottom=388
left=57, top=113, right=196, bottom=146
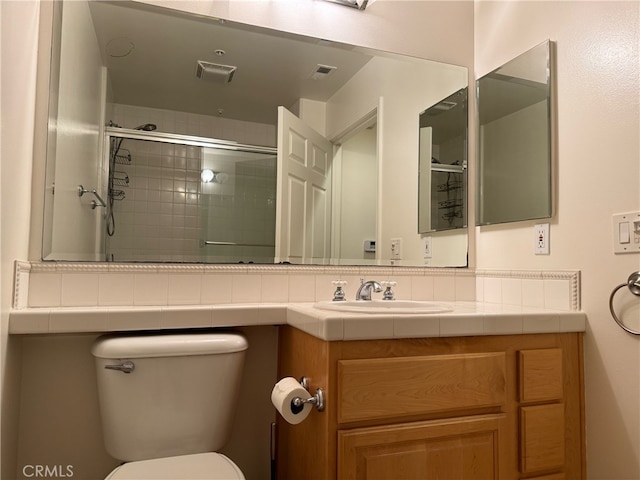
left=476, top=41, right=553, bottom=225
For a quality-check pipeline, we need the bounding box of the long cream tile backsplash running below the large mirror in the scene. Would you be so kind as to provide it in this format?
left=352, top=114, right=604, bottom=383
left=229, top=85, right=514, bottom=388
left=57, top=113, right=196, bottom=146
left=14, top=261, right=580, bottom=311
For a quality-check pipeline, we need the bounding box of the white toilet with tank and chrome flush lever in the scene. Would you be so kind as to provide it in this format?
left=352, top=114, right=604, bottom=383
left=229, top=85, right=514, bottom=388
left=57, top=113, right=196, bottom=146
left=91, top=332, right=248, bottom=480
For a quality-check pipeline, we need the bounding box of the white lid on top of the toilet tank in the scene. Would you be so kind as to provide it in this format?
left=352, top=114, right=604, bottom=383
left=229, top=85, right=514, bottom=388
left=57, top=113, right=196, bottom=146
left=91, top=332, right=249, bottom=358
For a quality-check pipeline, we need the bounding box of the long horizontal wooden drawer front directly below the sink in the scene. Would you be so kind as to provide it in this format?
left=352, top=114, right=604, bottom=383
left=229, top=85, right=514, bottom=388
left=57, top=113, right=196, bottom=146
left=338, top=352, right=506, bottom=422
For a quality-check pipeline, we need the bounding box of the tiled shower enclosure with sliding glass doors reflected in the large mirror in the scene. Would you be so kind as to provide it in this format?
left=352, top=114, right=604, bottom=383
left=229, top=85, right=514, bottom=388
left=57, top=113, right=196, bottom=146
left=105, top=126, right=276, bottom=263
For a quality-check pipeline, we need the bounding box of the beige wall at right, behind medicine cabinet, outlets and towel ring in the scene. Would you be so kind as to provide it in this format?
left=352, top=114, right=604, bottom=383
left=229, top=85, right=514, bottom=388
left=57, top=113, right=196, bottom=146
left=475, top=1, right=640, bottom=480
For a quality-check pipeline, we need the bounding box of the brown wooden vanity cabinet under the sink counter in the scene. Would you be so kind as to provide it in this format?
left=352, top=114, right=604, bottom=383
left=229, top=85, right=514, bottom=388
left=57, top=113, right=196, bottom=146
left=276, top=326, right=585, bottom=480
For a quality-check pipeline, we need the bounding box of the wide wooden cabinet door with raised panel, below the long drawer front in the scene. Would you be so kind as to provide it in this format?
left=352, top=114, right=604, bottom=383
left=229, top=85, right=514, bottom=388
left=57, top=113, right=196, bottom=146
left=338, top=414, right=506, bottom=480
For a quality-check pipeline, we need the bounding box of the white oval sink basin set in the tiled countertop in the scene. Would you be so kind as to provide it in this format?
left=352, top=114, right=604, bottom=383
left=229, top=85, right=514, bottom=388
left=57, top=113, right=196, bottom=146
left=314, top=300, right=453, bottom=315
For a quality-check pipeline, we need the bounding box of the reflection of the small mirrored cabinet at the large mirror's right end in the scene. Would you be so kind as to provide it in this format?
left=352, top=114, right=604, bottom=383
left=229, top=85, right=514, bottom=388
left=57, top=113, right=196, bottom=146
left=418, top=88, right=468, bottom=233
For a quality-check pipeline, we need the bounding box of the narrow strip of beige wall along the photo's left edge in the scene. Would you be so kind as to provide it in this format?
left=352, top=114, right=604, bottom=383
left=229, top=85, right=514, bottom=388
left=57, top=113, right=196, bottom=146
left=0, top=2, right=38, bottom=478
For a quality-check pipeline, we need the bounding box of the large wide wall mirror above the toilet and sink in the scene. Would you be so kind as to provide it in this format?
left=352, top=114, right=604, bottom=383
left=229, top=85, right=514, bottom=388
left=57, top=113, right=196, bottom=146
left=42, top=0, right=468, bottom=267
